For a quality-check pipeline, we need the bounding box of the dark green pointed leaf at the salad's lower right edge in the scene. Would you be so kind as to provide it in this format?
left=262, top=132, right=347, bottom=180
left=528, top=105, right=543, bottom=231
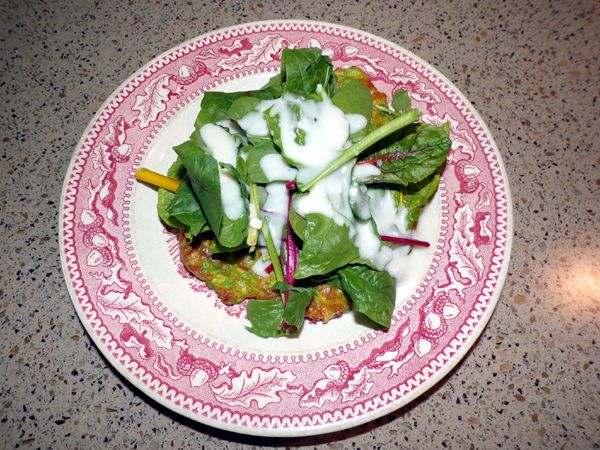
left=338, top=265, right=396, bottom=328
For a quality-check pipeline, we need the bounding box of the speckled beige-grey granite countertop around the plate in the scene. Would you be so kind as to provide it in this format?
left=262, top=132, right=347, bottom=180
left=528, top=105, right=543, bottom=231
left=0, top=0, right=600, bottom=449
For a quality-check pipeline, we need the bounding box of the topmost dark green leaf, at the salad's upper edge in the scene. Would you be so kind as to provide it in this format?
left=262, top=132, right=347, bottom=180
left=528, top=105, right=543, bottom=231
left=281, top=48, right=335, bottom=97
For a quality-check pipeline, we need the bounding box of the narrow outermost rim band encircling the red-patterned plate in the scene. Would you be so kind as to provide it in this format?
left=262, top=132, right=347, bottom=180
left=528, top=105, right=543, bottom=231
left=58, top=19, right=514, bottom=437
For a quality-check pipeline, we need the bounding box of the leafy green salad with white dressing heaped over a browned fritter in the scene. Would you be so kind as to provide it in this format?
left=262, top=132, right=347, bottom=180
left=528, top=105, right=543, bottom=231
left=136, top=48, right=451, bottom=337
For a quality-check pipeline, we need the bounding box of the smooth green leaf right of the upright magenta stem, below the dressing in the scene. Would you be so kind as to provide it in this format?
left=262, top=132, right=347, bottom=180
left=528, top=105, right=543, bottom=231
left=294, top=213, right=359, bottom=279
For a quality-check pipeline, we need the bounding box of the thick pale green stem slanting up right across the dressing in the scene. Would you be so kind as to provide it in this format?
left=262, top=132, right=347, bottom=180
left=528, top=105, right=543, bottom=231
left=299, top=109, right=419, bottom=192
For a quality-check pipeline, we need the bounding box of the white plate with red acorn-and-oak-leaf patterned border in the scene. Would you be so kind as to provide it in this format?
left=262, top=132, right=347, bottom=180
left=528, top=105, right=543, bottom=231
left=60, top=21, right=512, bottom=436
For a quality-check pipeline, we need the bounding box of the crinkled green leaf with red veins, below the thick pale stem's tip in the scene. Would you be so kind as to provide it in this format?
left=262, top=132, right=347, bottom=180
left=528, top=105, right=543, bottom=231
left=358, top=124, right=451, bottom=186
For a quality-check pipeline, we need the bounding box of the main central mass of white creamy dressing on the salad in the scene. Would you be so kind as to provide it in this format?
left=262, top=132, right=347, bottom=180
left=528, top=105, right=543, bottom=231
left=230, top=86, right=418, bottom=281
